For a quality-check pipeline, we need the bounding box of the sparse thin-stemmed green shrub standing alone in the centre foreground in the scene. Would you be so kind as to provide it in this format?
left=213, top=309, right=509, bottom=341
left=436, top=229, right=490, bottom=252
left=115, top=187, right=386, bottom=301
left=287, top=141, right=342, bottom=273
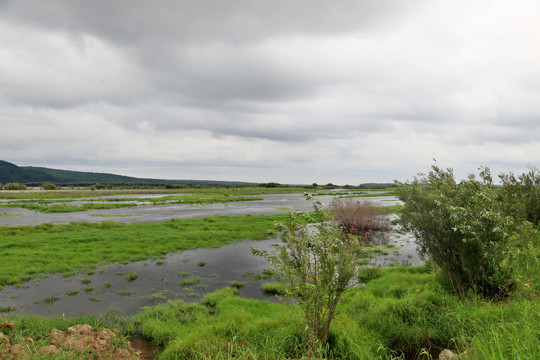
left=252, top=197, right=360, bottom=356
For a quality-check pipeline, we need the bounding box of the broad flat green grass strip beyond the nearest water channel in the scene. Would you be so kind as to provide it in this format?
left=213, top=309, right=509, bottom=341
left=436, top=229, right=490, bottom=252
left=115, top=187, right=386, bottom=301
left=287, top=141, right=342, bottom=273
left=0, top=215, right=285, bottom=287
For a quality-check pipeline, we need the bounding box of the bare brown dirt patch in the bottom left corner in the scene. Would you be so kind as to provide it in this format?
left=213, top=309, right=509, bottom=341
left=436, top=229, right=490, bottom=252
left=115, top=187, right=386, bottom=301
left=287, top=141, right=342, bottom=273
left=0, top=324, right=147, bottom=360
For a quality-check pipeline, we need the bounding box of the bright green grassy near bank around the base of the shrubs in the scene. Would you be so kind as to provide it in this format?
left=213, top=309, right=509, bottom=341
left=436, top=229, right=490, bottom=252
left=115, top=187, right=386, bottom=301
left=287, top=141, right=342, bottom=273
left=1, top=266, right=540, bottom=360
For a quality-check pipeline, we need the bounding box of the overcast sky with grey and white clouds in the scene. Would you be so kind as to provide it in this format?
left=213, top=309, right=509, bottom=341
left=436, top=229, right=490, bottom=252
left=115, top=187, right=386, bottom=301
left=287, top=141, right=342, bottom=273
left=0, top=0, right=540, bottom=185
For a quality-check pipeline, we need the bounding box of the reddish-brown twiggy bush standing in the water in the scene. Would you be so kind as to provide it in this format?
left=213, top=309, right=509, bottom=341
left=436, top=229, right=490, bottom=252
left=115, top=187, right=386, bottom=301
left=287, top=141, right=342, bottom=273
left=329, top=198, right=390, bottom=235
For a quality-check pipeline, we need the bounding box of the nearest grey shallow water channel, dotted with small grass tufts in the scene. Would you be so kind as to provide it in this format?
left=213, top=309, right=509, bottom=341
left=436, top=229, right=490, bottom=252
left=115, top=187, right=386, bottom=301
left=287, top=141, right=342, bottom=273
left=0, top=226, right=422, bottom=317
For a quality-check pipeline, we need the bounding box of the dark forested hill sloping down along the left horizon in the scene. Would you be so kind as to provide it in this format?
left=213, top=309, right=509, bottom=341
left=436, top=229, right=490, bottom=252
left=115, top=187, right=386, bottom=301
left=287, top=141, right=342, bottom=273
left=0, top=160, right=247, bottom=186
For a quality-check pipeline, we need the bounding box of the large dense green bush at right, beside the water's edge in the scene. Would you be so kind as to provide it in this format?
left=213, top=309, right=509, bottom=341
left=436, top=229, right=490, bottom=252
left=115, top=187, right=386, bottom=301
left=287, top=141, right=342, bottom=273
left=395, top=165, right=512, bottom=296
